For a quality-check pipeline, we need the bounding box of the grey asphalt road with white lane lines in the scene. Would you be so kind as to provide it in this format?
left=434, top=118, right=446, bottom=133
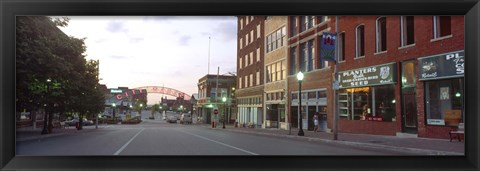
left=17, top=115, right=412, bottom=156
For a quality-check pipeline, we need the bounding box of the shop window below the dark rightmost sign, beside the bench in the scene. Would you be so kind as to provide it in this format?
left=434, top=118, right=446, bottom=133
left=425, top=78, right=464, bottom=126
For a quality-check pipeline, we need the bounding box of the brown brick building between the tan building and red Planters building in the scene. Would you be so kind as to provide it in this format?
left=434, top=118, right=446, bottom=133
left=287, top=16, right=334, bottom=130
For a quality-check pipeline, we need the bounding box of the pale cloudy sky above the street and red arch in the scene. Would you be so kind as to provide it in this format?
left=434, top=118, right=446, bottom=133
left=60, top=16, right=237, bottom=104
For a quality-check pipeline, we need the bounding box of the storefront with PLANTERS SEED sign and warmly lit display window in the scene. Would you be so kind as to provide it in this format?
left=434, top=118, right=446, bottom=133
left=337, top=62, right=397, bottom=135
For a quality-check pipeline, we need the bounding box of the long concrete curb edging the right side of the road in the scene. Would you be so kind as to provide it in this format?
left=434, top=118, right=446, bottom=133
left=213, top=128, right=464, bottom=156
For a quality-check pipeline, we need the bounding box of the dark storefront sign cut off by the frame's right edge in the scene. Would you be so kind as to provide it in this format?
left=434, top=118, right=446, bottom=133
left=418, top=50, right=465, bottom=80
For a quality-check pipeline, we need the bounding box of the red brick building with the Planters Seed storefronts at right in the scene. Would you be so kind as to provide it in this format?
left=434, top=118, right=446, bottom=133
left=332, top=16, right=464, bottom=138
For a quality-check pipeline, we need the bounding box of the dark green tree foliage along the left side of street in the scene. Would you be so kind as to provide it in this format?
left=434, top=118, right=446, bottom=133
left=16, top=16, right=104, bottom=133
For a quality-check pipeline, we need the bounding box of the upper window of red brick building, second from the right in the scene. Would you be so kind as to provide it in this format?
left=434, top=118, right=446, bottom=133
left=400, top=16, right=415, bottom=46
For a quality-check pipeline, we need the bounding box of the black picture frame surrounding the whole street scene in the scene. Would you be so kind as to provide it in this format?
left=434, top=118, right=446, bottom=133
left=0, top=0, right=480, bottom=170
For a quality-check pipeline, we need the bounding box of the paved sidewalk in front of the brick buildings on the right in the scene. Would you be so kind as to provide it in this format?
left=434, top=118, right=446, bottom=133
left=203, top=124, right=465, bottom=155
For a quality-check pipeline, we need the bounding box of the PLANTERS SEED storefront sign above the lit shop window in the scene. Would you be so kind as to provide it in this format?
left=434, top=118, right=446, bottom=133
left=338, top=63, right=397, bottom=88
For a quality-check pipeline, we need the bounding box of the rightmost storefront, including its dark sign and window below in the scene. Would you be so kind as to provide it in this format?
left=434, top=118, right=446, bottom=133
left=418, top=50, right=465, bottom=138
